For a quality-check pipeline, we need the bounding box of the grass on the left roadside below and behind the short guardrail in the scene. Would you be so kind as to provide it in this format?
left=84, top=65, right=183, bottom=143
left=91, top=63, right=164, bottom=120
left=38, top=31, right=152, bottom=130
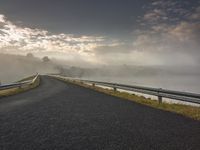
left=0, top=76, right=40, bottom=98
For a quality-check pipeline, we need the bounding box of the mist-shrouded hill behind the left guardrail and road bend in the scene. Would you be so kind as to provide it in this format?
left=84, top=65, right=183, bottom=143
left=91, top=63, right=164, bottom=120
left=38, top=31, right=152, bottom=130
left=0, top=53, right=58, bottom=83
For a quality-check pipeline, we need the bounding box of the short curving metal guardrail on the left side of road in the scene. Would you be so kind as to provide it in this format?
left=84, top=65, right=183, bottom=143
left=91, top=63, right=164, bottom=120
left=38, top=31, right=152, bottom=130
left=0, top=74, right=39, bottom=90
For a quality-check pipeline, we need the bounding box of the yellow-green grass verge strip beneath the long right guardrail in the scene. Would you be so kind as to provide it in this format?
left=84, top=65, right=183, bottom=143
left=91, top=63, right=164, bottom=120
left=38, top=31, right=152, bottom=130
left=55, top=78, right=200, bottom=120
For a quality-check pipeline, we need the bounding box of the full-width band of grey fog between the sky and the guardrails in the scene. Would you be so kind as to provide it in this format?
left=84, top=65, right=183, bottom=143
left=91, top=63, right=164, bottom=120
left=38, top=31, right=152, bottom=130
left=0, top=54, right=200, bottom=93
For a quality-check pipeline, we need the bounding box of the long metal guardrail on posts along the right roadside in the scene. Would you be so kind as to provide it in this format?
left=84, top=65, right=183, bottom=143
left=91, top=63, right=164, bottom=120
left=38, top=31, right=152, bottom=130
left=57, top=76, right=200, bottom=104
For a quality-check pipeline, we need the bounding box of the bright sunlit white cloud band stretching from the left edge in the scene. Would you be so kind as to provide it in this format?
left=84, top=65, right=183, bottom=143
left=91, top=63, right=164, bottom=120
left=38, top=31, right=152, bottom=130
left=0, top=15, right=129, bottom=64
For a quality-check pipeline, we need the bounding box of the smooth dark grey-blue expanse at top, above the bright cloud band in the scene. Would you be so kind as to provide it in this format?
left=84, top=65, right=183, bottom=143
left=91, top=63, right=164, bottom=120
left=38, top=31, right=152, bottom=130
left=0, top=0, right=149, bottom=36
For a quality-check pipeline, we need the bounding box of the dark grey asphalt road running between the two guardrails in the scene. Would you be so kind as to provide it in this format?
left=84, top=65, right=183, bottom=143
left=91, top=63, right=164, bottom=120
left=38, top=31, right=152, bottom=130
left=0, top=77, right=200, bottom=150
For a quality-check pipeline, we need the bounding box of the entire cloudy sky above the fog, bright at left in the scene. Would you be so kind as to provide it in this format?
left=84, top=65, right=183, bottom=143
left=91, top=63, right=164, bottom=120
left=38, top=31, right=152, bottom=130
left=0, top=0, right=200, bottom=66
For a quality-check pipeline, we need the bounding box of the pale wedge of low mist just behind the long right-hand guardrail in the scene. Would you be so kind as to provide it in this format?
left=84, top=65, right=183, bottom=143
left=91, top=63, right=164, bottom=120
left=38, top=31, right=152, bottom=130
left=82, top=75, right=200, bottom=93
